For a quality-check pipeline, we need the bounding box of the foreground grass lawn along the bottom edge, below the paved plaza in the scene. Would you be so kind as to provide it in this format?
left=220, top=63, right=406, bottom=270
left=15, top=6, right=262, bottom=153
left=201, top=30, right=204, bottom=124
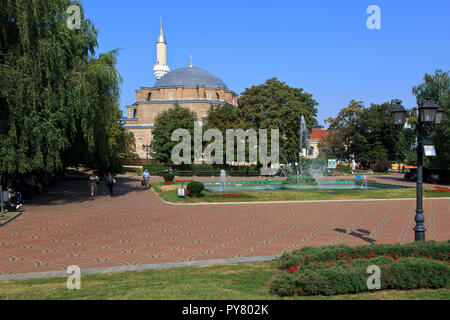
left=0, top=261, right=450, bottom=300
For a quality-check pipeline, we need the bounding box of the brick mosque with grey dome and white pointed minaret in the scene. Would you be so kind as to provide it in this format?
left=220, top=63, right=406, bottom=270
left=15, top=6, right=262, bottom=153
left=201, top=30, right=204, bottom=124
left=124, top=19, right=237, bottom=159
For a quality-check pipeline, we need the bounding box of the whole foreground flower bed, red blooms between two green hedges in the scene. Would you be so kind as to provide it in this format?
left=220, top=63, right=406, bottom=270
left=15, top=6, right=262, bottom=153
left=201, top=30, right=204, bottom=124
left=271, top=241, right=450, bottom=296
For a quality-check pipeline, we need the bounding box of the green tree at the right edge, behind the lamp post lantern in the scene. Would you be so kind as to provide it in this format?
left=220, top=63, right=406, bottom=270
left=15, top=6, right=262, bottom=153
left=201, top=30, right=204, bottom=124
left=412, top=70, right=450, bottom=169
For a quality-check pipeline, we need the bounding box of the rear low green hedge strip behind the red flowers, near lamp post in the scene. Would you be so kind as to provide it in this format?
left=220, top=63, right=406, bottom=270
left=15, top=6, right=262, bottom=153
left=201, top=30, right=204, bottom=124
left=278, top=240, right=450, bottom=269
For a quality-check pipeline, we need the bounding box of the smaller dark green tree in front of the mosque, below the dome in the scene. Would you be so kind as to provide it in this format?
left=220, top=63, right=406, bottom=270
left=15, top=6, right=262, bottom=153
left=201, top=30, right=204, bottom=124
left=151, top=103, right=197, bottom=163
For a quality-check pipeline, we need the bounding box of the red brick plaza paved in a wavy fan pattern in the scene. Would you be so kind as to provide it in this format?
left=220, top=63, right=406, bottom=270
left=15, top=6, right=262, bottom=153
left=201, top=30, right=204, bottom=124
left=0, top=177, right=450, bottom=275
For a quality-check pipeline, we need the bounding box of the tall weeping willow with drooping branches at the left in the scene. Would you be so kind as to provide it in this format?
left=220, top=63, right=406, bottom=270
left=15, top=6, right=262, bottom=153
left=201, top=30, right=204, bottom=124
left=0, top=0, right=133, bottom=175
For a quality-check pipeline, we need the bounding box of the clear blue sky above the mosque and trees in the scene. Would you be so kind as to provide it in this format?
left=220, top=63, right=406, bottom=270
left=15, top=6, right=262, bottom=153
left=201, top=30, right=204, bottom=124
left=81, top=0, right=450, bottom=124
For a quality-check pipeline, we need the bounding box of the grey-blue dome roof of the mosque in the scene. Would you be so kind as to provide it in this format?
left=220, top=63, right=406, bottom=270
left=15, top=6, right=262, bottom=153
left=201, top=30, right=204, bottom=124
left=154, top=67, right=228, bottom=89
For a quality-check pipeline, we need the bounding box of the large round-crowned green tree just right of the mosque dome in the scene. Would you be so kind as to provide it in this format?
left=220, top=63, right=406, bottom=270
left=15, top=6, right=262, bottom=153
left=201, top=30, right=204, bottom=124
left=238, top=78, right=318, bottom=162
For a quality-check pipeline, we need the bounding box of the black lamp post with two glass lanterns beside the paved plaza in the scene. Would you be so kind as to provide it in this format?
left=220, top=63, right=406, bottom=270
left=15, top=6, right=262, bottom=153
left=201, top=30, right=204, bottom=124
left=391, top=101, right=444, bottom=241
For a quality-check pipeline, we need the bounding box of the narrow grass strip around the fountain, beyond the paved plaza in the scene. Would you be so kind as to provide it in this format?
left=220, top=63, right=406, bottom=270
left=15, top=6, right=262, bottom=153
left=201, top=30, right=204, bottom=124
left=153, top=183, right=450, bottom=203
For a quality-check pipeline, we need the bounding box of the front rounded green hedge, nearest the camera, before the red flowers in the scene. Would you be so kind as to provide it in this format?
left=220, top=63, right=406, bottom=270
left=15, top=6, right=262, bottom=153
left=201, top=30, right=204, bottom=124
left=271, top=257, right=450, bottom=296
